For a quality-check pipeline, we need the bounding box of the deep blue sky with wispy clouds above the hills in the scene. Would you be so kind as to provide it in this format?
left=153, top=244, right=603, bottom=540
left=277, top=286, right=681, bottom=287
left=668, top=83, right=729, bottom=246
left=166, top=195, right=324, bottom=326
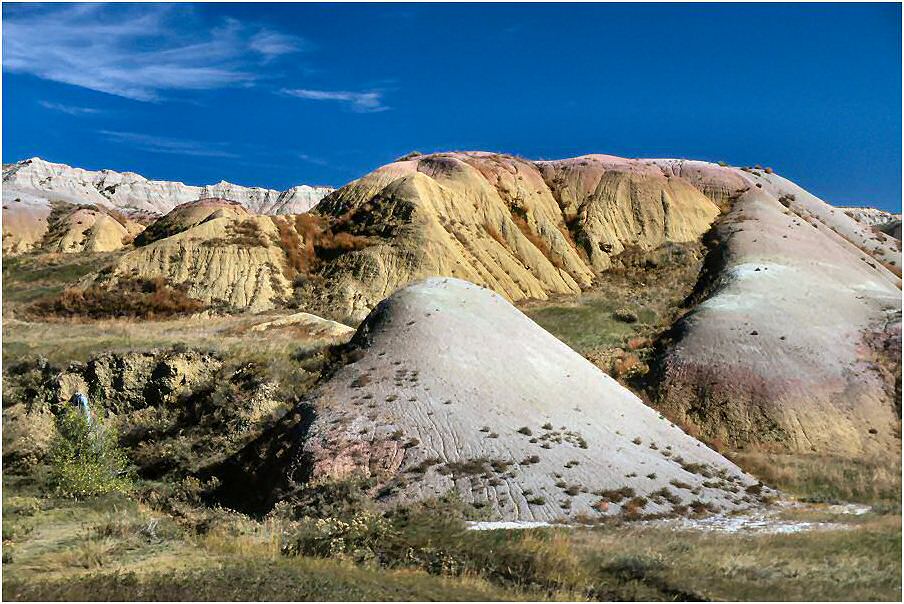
left=3, top=3, right=901, bottom=210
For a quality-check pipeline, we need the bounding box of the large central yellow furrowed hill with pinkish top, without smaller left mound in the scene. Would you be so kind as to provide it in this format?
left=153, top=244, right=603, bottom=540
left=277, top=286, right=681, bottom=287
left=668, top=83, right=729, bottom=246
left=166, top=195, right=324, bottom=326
left=314, top=153, right=719, bottom=318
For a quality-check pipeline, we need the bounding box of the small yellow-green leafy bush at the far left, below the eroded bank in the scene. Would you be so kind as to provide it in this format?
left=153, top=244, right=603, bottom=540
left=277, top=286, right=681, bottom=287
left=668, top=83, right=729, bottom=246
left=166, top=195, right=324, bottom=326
left=50, top=409, right=132, bottom=498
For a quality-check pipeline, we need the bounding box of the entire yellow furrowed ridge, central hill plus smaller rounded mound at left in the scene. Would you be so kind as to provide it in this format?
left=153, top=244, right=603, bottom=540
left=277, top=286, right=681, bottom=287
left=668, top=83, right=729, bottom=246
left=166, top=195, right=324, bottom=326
left=81, top=152, right=719, bottom=320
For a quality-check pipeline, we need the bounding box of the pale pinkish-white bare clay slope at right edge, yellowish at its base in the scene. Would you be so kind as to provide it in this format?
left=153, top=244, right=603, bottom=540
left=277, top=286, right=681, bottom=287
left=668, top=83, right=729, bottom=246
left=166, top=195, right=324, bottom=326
left=660, top=170, right=901, bottom=456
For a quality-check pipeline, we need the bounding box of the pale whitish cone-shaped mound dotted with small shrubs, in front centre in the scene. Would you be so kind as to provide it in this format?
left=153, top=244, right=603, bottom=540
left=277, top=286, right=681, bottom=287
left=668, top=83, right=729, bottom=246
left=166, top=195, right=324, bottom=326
left=301, top=277, right=760, bottom=521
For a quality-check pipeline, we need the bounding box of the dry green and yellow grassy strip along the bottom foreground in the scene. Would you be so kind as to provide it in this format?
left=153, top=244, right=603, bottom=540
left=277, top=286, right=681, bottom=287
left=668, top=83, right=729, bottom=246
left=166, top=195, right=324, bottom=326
left=3, top=477, right=901, bottom=600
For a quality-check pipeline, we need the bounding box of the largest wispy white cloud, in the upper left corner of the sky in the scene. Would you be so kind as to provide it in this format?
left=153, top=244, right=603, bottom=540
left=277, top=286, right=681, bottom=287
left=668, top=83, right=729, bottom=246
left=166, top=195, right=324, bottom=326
left=3, top=4, right=304, bottom=101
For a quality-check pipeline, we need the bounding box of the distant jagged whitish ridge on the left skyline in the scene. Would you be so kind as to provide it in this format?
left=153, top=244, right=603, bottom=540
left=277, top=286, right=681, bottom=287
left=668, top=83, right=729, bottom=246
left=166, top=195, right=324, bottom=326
left=3, top=157, right=332, bottom=254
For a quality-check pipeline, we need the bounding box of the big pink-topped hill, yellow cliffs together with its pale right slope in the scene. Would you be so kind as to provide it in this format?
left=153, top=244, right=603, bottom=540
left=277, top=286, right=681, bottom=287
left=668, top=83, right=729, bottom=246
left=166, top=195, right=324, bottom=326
left=314, top=153, right=901, bottom=456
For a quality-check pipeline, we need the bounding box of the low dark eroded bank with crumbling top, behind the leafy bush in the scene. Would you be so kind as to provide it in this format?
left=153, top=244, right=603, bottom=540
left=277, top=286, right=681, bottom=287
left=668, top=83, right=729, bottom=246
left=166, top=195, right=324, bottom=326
left=3, top=347, right=306, bottom=480
